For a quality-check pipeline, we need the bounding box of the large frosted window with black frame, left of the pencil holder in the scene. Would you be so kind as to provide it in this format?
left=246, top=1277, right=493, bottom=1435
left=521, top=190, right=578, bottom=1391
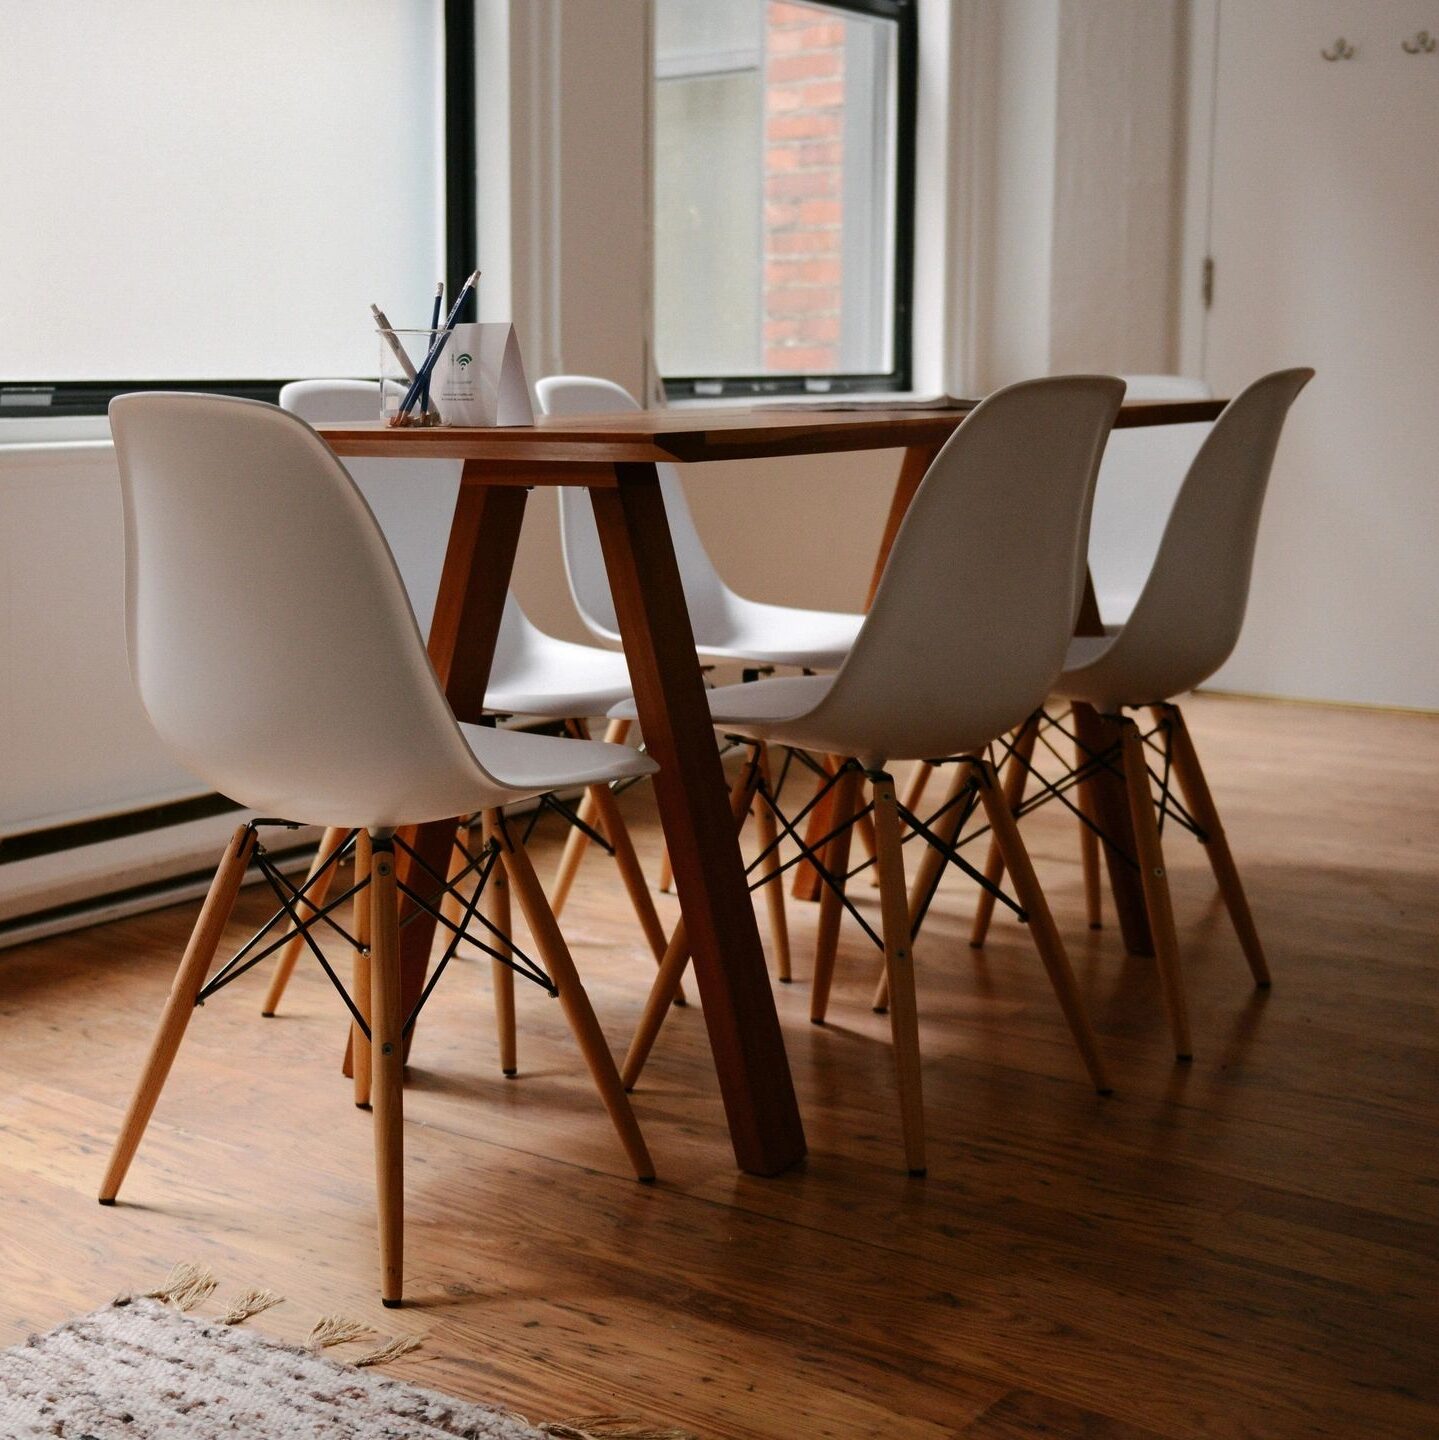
left=0, top=0, right=475, bottom=418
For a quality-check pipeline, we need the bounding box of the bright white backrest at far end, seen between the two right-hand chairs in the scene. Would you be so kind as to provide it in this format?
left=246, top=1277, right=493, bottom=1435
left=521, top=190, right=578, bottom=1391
left=1089, top=374, right=1213, bottom=624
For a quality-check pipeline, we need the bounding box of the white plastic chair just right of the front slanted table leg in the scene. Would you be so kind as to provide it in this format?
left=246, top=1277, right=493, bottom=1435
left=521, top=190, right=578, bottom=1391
left=607, top=376, right=1124, bottom=1174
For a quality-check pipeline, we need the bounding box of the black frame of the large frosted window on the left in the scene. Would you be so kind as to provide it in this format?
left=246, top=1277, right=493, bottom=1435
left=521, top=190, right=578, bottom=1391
left=0, top=0, right=480, bottom=420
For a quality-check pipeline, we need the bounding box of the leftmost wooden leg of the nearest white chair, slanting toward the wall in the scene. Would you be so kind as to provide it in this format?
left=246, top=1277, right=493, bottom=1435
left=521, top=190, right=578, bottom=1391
left=99, top=825, right=255, bottom=1205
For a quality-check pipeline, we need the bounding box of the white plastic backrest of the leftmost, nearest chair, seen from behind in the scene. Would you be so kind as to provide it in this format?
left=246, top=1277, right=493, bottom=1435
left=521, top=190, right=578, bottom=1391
left=109, top=392, right=489, bottom=824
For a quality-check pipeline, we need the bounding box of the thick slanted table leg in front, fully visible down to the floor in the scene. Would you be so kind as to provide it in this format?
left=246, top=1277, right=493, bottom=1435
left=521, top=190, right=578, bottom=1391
left=591, top=465, right=805, bottom=1175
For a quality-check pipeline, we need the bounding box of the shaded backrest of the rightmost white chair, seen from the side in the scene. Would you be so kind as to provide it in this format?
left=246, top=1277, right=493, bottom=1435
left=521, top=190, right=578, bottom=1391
left=1088, top=367, right=1314, bottom=700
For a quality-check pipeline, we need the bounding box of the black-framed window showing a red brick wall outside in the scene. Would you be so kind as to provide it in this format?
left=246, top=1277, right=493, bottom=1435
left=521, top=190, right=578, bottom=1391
left=654, top=0, right=916, bottom=396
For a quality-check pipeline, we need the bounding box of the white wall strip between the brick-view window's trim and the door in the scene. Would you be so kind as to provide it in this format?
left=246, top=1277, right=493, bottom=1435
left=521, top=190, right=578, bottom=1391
left=951, top=0, right=1184, bottom=390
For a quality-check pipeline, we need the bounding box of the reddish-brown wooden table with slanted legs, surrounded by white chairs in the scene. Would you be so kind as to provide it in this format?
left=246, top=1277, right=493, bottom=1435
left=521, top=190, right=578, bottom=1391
left=318, top=402, right=1220, bottom=1175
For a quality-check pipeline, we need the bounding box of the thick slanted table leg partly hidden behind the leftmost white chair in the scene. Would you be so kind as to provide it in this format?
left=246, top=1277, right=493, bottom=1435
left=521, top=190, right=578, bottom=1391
left=346, top=478, right=529, bottom=1074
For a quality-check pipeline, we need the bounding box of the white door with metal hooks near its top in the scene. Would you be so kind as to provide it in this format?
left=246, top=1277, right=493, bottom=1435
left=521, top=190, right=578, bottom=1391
left=1204, top=0, right=1439, bottom=710
